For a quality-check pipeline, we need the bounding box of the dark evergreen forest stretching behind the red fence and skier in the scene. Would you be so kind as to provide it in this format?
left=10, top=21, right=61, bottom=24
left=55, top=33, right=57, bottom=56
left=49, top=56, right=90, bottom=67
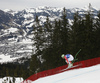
left=0, top=7, right=100, bottom=79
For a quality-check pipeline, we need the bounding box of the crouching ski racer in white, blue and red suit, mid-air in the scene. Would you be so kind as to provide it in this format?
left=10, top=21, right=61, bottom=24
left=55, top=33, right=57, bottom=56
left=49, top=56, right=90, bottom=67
left=61, top=54, right=74, bottom=68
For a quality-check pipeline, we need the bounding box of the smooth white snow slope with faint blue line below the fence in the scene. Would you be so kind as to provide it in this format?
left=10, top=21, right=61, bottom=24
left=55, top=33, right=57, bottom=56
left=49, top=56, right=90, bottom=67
left=32, top=65, right=100, bottom=83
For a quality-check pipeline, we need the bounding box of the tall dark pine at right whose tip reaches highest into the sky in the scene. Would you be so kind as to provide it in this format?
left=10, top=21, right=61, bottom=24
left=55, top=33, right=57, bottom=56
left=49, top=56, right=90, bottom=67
left=84, top=12, right=95, bottom=59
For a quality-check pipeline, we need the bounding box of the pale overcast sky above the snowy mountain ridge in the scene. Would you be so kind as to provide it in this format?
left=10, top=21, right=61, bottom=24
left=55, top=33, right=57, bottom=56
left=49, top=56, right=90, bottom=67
left=0, top=0, right=100, bottom=10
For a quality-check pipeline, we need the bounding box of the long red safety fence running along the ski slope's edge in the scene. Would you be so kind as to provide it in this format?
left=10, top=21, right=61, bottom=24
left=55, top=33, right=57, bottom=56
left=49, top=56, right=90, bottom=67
left=22, top=57, right=100, bottom=83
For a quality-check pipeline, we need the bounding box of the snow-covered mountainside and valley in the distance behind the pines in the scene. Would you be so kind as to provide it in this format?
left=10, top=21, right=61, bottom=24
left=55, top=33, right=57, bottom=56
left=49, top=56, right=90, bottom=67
left=0, top=6, right=98, bottom=63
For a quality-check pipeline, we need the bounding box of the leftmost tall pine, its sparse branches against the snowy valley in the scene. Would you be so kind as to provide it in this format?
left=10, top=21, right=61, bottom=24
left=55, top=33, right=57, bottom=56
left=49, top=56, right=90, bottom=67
left=33, top=16, right=43, bottom=52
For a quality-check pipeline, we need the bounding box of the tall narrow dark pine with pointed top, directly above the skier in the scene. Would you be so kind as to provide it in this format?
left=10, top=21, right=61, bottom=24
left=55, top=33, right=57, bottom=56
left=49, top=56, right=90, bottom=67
left=60, top=8, right=69, bottom=53
